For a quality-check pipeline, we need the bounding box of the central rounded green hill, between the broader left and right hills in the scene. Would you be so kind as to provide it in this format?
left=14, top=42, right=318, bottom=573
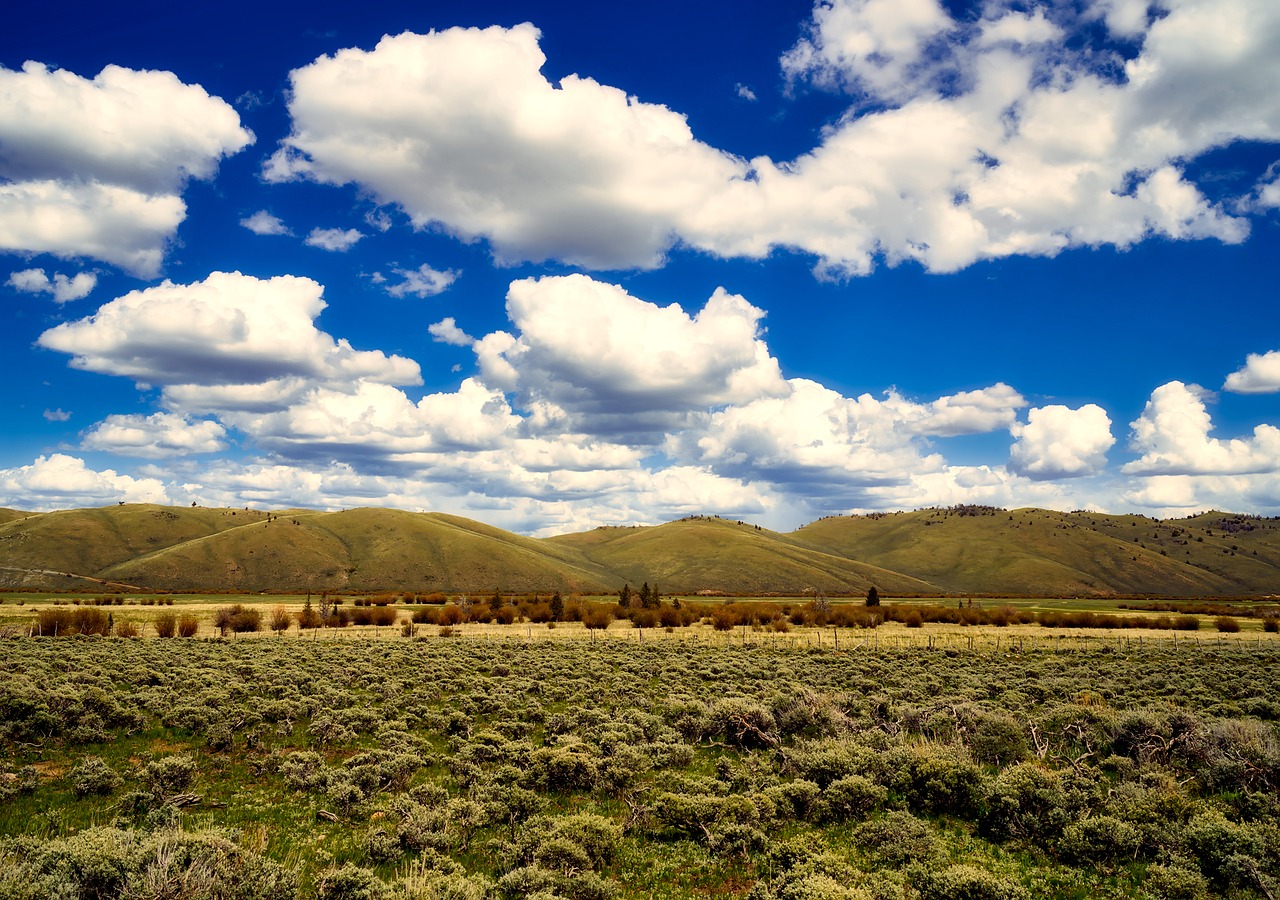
left=547, top=516, right=937, bottom=594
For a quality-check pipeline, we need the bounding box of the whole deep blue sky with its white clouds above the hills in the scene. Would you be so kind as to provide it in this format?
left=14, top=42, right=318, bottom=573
left=0, top=0, right=1280, bottom=534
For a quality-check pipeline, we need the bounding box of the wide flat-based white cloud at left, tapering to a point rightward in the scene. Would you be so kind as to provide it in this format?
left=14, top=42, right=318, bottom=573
left=38, top=267, right=421, bottom=407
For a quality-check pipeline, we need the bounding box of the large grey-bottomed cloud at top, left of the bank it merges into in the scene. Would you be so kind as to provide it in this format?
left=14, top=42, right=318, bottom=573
left=264, top=24, right=744, bottom=269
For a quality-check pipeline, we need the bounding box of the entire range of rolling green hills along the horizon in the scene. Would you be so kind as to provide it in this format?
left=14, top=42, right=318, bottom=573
left=0, top=504, right=1280, bottom=597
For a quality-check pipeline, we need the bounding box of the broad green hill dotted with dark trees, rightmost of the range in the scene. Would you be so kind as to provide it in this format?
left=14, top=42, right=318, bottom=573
left=794, top=508, right=1280, bottom=597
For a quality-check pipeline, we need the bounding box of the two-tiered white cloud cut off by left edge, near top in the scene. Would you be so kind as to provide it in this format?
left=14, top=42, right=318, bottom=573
left=0, top=63, right=253, bottom=277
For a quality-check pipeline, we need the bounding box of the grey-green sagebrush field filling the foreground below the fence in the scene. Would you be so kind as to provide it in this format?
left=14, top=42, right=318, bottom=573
left=0, top=634, right=1280, bottom=900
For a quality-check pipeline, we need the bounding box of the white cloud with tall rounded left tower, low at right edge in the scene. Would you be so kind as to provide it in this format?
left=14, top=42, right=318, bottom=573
left=1123, top=382, right=1280, bottom=475
